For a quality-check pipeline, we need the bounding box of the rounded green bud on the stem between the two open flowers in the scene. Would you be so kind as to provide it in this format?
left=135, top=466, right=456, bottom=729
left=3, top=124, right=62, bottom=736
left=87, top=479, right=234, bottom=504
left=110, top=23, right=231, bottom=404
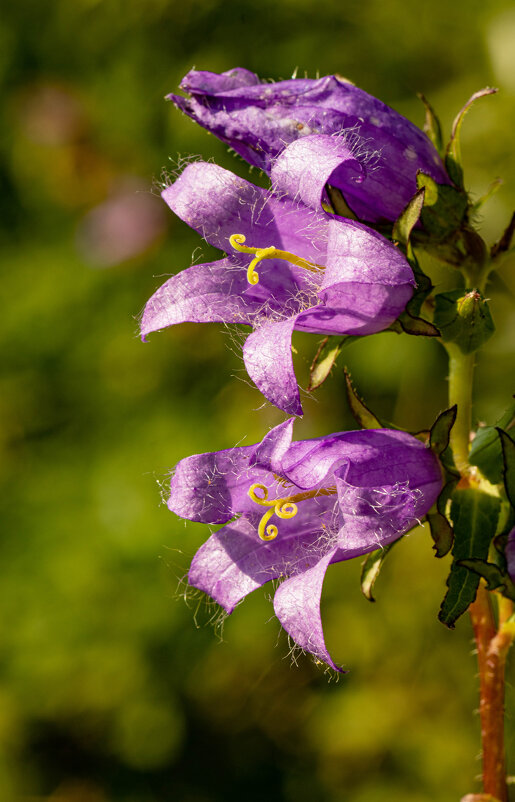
left=433, top=290, right=495, bottom=354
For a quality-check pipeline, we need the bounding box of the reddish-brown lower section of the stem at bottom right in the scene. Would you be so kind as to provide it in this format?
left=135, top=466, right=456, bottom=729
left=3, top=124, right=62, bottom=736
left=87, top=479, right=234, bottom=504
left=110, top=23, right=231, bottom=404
left=469, top=582, right=512, bottom=802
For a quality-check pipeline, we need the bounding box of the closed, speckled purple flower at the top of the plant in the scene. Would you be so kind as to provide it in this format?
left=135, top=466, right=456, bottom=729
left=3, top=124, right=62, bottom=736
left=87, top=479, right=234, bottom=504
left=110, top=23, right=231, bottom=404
left=168, top=67, right=449, bottom=222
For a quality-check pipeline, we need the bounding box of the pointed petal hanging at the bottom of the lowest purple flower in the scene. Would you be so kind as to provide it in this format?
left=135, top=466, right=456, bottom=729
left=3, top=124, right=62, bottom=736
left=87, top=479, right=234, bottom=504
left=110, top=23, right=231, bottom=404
left=274, top=549, right=343, bottom=671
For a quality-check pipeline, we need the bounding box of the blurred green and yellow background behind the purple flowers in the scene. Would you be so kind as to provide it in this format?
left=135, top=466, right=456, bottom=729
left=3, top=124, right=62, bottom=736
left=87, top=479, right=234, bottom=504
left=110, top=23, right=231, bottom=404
left=0, top=0, right=515, bottom=802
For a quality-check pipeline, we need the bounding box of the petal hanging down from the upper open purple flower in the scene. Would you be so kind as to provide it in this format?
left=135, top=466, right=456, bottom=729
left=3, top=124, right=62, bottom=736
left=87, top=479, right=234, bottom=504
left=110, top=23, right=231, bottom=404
left=243, top=317, right=302, bottom=415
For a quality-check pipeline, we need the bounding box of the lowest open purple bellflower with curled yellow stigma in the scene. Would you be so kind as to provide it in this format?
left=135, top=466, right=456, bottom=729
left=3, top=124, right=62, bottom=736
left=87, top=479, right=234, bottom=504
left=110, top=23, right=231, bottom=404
left=168, top=419, right=442, bottom=671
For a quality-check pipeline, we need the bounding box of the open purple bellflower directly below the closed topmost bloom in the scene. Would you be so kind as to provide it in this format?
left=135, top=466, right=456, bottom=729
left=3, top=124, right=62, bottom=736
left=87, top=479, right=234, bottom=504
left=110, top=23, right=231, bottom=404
left=141, top=160, right=415, bottom=415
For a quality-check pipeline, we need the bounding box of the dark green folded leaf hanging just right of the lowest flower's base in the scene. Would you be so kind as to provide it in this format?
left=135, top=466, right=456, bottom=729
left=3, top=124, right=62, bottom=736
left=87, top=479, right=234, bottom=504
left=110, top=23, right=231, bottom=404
left=438, top=488, right=501, bottom=629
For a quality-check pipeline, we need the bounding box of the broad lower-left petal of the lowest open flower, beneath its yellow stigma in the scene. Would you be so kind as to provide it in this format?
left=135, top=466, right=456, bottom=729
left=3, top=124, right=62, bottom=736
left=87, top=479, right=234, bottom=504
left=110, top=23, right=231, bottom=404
left=188, top=497, right=335, bottom=613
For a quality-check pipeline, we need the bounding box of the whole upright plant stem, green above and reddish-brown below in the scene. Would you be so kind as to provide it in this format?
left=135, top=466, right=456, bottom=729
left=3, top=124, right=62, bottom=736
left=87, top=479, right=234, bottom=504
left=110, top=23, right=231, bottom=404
left=445, top=343, right=515, bottom=802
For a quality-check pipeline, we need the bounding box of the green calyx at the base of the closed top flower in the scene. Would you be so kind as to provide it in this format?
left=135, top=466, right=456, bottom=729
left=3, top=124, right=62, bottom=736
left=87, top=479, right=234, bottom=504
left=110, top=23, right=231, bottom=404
left=417, top=172, right=468, bottom=241
